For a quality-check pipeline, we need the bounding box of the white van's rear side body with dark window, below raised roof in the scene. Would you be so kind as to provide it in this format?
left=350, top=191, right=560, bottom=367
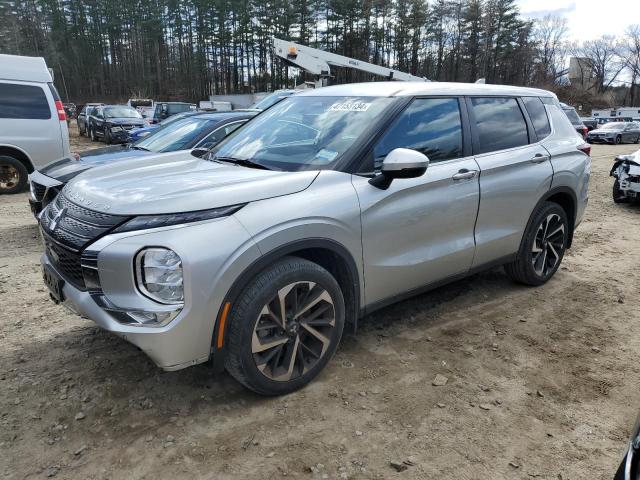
left=0, top=81, right=68, bottom=168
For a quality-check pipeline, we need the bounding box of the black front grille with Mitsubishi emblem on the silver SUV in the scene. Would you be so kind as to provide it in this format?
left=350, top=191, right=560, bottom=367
left=40, top=192, right=128, bottom=290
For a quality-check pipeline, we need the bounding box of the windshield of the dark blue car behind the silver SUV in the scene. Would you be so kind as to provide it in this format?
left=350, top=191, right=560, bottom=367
left=135, top=118, right=217, bottom=153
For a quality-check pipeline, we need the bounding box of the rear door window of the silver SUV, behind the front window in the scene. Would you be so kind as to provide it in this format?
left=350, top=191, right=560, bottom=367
left=471, top=97, right=529, bottom=153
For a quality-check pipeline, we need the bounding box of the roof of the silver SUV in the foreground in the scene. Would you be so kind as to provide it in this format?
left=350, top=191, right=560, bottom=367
left=296, top=82, right=556, bottom=98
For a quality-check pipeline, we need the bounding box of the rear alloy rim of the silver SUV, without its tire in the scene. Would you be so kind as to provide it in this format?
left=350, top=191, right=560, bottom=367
left=531, top=213, right=565, bottom=277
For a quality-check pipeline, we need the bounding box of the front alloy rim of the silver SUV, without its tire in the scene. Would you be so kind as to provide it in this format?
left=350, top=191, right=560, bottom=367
left=251, top=281, right=336, bottom=382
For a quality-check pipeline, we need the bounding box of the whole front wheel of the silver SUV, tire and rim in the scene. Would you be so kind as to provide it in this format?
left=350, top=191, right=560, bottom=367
left=224, top=257, right=345, bottom=396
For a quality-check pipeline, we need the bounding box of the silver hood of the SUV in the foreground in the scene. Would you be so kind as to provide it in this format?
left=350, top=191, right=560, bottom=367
left=64, top=152, right=318, bottom=215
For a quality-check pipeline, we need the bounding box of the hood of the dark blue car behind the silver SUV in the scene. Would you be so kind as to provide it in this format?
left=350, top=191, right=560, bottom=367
left=40, top=145, right=153, bottom=183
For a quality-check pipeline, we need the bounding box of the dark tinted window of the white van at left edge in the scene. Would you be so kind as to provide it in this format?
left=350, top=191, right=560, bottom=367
left=0, top=83, right=51, bottom=120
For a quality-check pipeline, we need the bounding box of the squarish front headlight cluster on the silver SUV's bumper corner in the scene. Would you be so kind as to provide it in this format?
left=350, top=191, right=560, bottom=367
left=135, top=247, right=184, bottom=305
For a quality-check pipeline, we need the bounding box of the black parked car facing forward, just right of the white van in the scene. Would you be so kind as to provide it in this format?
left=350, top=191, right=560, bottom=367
left=87, top=105, right=145, bottom=145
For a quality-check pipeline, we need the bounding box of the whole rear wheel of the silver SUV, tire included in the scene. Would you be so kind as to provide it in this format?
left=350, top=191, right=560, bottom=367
left=504, top=202, right=569, bottom=286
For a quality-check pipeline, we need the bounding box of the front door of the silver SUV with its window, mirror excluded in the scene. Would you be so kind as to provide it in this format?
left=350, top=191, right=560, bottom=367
left=353, top=98, right=480, bottom=305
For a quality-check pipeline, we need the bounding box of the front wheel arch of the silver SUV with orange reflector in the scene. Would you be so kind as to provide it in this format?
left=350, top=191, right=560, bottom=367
left=212, top=238, right=361, bottom=371
